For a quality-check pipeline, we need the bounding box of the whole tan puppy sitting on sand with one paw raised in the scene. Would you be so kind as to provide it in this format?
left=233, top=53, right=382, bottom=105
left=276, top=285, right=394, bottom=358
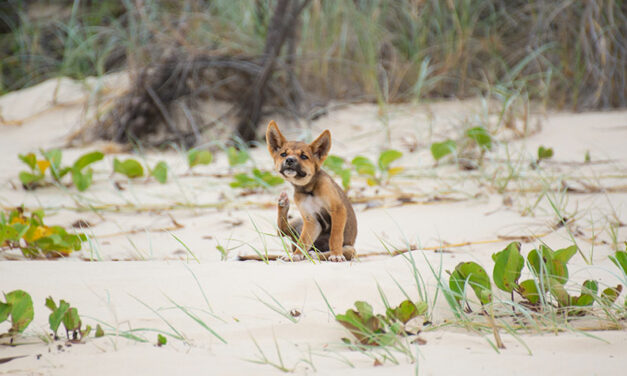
left=266, top=121, right=357, bottom=261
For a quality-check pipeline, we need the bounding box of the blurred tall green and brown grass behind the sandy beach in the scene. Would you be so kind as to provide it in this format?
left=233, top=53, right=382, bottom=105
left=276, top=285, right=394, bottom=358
left=0, top=0, right=627, bottom=142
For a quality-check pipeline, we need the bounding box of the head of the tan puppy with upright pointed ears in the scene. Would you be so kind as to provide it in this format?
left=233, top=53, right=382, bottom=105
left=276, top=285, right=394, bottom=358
left=266, top=120, right=331, bottom=185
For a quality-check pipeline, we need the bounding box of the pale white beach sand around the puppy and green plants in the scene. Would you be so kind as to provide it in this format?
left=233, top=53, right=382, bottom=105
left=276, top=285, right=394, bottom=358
left=0, top=78, right=627, bottom=375
